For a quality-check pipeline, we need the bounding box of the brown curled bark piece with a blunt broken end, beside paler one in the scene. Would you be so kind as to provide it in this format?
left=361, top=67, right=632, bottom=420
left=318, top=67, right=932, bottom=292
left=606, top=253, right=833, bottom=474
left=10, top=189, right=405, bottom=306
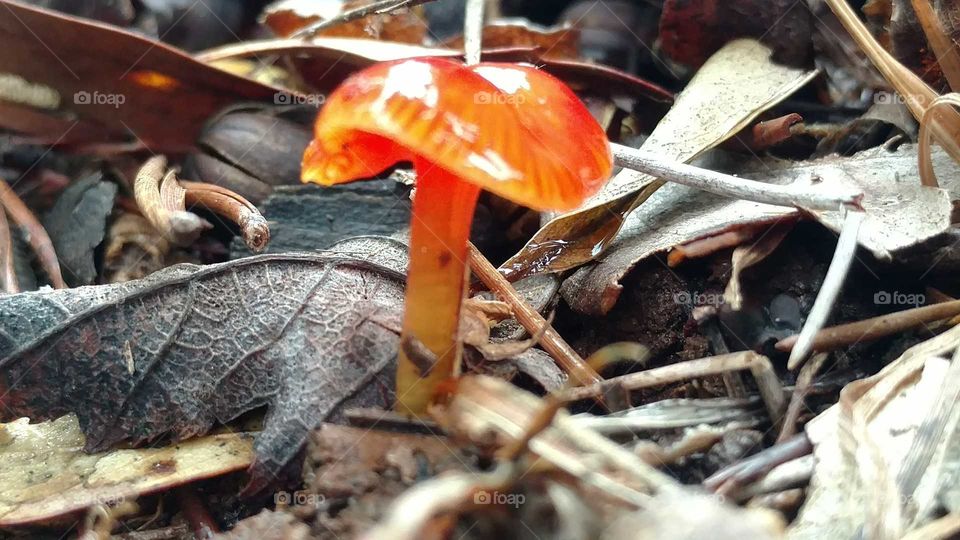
left=180, top=181, right=270, bottom=253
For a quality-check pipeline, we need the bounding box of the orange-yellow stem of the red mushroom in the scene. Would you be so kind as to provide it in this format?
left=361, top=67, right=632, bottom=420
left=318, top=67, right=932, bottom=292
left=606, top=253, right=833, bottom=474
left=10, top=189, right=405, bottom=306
left=396, top=158, right=480, bottom=415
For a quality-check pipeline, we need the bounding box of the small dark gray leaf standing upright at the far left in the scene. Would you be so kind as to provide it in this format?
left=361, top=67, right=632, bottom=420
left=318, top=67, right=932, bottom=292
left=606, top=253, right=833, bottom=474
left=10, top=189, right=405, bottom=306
left=43, top=174, right=117, bottom=287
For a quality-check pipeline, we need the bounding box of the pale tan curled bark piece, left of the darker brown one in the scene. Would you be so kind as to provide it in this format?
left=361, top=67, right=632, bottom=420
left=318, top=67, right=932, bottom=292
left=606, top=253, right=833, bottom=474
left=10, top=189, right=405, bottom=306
left=133, top=156, right=212, bottom=246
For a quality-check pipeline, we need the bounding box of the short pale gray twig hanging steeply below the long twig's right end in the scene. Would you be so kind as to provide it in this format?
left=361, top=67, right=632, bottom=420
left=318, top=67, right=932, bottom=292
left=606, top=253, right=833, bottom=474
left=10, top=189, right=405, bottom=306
left=787, top=210, right=866, bottom=370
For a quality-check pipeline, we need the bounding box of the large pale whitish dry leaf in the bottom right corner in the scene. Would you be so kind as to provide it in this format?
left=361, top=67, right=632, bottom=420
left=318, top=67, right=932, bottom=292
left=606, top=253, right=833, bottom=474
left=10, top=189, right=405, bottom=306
left=788, top=327, right=960, bottom=540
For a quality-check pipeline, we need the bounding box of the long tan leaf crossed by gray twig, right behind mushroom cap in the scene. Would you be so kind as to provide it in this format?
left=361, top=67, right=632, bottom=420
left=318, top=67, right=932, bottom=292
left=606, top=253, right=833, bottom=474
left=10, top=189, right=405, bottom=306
left=501, top=40, right=815, bottom=279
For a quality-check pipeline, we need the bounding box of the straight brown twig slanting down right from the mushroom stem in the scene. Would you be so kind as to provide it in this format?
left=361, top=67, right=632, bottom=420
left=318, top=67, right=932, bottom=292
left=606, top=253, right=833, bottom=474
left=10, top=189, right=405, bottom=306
left=467, top=243, right=602, bottom=385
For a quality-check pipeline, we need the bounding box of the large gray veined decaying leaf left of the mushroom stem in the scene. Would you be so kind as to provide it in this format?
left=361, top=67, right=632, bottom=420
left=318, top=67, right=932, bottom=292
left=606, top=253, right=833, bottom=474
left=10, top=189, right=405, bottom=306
left=0, top=238, right=406, bottom=487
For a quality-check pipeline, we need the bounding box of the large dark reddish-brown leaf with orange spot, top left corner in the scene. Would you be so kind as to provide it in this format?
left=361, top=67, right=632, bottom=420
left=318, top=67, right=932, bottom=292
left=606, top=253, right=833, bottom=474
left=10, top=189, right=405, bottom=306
left=0, top=0, right=279, bottom=152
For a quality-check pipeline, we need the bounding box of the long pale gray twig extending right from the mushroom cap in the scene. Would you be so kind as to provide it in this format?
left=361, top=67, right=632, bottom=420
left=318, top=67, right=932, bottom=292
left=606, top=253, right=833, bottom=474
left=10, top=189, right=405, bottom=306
left=610, top=143, right=863, bottom=210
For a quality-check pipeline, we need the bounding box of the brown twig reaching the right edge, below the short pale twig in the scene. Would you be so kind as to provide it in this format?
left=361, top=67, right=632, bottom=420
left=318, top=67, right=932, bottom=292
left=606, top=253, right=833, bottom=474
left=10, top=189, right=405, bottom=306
left=775, top=300, right=960, bottom=351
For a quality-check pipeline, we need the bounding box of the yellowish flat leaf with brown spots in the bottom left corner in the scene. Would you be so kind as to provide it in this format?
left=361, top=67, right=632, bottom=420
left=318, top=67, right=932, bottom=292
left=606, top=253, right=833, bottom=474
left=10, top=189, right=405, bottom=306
left=0, top=416, right=254, bottom=527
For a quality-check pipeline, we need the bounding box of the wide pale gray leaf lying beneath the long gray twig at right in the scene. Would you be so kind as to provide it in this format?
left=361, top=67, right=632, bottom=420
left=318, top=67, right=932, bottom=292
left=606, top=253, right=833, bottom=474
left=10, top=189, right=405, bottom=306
left=560, top=145, right=960, bottom=315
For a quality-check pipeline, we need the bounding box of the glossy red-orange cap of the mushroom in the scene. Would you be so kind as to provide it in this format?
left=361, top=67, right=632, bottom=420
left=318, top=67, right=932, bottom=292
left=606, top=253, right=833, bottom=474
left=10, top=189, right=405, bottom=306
left=303, top=58, right=613, bottom=210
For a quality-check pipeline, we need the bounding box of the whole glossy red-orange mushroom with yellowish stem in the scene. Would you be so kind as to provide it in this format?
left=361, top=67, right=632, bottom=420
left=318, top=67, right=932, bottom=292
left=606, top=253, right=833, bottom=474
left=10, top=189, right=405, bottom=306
left=303, top=59, right=612, bottom=413
